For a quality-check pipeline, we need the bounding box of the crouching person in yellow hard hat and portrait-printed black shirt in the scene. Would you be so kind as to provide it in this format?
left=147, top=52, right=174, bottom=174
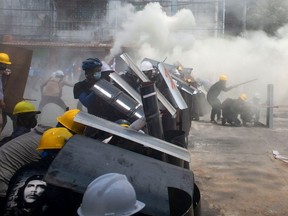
left=3, top=127, right=80, bottom=216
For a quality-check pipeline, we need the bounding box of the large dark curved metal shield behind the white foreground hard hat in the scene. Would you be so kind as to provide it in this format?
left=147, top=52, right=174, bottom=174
left=45, top=135, right=194, bottom=216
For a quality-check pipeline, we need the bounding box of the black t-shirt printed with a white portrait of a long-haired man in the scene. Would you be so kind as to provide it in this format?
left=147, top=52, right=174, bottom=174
left=4, top=159, right=82, bottom=216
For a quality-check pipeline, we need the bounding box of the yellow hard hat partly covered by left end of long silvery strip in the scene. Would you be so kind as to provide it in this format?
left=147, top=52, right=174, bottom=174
left=57, top=109, right=85, bottom=134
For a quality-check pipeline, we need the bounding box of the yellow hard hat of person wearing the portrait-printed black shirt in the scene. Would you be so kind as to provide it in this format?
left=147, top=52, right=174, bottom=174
left=37, top=127, right=73, bottom=150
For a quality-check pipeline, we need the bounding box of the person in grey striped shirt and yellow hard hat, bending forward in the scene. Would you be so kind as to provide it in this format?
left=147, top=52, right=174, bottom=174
left=0, top=109, right=85, bottom=215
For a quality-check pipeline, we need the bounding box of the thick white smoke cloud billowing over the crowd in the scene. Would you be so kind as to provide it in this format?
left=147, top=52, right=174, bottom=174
left=110, top=3, right=288, bottom=104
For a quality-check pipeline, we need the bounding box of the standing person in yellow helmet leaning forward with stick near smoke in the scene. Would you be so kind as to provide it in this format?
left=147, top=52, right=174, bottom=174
left=207, top=75, right=232, bottom=123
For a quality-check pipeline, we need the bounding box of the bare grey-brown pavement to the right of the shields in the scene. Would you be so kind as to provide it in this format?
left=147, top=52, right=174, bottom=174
left=188, top=109, right=288, bottom=216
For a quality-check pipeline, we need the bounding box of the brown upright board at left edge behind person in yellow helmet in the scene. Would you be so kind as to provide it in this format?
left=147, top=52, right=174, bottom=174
left=0, top=44, right=33, bottom=114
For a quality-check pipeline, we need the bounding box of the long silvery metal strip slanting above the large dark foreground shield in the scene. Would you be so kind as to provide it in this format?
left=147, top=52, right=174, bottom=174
left=74, top=111, right=191, bottom=162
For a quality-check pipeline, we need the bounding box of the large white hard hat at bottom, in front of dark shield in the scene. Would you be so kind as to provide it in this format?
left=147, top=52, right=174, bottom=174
left=77, top=173, right=145, bottom=216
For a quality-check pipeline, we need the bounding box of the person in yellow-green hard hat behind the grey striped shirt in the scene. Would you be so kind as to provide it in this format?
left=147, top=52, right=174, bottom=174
left=0, top=100, right=41, bottom=146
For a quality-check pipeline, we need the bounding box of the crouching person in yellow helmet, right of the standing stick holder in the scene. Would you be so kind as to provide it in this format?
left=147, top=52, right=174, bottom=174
left=222, top=94, right=247, bottom=127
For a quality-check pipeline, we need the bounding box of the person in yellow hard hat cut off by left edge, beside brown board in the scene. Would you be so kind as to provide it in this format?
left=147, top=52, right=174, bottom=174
left=0, top=53, right=12, bottom=134
